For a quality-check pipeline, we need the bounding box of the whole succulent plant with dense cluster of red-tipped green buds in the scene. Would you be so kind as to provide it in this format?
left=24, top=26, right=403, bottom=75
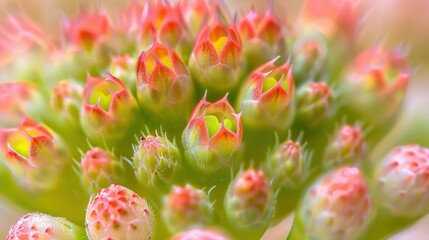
left=0, top=0, right=429, bottom=240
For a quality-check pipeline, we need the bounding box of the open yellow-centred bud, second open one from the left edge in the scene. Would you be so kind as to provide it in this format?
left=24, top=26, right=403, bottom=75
left=81, top=73, right=136, bottom=140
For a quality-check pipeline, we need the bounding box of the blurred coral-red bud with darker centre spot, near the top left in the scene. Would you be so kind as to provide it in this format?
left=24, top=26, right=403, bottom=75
left=62, top=12, right=110, bottom=49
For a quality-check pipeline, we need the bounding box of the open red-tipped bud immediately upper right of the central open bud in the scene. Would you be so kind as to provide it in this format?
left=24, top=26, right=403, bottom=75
left=238, top=60, right=295, bottom=131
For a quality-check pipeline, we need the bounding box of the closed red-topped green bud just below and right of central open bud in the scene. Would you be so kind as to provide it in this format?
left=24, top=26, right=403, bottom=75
left=225, top=169, right=273, bottom=229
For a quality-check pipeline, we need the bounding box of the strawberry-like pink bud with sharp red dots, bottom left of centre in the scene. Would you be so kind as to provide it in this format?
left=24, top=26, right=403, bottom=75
left=85, top=185, right=154, bottom=240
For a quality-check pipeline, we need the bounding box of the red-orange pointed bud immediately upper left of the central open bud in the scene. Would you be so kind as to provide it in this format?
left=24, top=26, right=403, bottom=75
left=137, top=42, right=193, bottom=114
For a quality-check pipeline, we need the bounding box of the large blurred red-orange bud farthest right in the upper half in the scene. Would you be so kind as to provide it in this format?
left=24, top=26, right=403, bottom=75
left=344, top=47, right=410, bottom=123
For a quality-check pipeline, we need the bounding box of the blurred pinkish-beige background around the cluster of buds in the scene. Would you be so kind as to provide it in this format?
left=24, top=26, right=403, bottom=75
left=0, top=0, right=429, bottom=240
